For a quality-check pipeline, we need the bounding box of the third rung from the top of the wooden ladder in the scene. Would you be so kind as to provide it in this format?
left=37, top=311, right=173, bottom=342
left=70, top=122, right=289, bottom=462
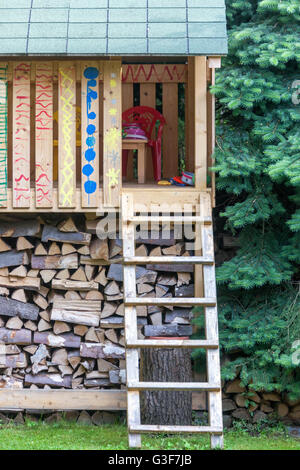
left=124, top=297, right=217, bottom=307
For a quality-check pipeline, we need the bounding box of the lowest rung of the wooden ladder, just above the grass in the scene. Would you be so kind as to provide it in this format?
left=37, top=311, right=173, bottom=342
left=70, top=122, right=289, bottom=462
left=128, top=424, right=223, bottom=434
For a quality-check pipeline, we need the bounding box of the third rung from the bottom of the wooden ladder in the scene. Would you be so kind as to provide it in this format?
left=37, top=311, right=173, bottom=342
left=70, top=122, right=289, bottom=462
left=126, top=339, right=219, bottom=349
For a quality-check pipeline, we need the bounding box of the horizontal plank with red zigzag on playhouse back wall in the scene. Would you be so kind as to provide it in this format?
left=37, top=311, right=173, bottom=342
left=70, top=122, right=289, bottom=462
left=122, top=64, right=187, bottom=83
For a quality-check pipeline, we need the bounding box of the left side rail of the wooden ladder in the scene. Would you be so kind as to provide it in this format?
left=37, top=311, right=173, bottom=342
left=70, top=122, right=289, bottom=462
left=122, top=194, right=141, bottom=447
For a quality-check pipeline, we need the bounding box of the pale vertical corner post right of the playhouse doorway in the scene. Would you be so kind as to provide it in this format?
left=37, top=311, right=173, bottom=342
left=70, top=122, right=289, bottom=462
left=195, top=56, right=207, bottom=190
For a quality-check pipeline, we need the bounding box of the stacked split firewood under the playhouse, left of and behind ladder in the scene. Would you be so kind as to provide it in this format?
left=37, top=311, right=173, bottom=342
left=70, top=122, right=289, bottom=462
left=0, top=214, right=194, bottom=389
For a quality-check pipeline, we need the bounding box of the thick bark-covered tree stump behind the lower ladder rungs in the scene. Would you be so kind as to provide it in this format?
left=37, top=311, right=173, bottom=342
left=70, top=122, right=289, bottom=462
left=141, top=348, right=192, bottom=426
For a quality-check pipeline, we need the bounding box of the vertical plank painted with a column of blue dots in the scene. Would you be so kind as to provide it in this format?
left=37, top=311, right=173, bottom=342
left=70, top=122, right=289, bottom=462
left=81, top=62, right=100, bottom=208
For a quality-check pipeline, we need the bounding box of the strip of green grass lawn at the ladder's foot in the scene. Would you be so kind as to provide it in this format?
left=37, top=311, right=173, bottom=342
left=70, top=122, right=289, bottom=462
left=0, top=422, right=300, bottom=450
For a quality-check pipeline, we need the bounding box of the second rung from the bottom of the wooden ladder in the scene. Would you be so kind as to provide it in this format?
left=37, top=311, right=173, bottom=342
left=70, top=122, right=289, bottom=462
left=127, top=382, right=221, bottom=392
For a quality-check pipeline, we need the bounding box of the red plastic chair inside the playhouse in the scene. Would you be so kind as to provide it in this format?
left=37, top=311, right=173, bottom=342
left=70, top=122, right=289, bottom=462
left=122, top=106, right=166, bottom=181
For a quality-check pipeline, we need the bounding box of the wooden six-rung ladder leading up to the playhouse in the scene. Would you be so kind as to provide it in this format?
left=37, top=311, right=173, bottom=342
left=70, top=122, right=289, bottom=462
left=122, top=193, right=223, bottom=448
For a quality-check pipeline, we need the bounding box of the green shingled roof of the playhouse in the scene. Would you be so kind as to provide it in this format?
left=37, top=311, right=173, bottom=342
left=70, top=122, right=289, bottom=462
left=0, top=0, right=227, bottom=56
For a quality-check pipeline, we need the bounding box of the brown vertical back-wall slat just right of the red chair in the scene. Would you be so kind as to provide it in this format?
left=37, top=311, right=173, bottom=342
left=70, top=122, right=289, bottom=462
left=163, top=83, right=178, bottom=178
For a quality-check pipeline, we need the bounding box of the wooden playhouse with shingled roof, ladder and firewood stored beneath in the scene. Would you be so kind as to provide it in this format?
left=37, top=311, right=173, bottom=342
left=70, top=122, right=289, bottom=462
left=0, top=0, right=227, bottom=447
